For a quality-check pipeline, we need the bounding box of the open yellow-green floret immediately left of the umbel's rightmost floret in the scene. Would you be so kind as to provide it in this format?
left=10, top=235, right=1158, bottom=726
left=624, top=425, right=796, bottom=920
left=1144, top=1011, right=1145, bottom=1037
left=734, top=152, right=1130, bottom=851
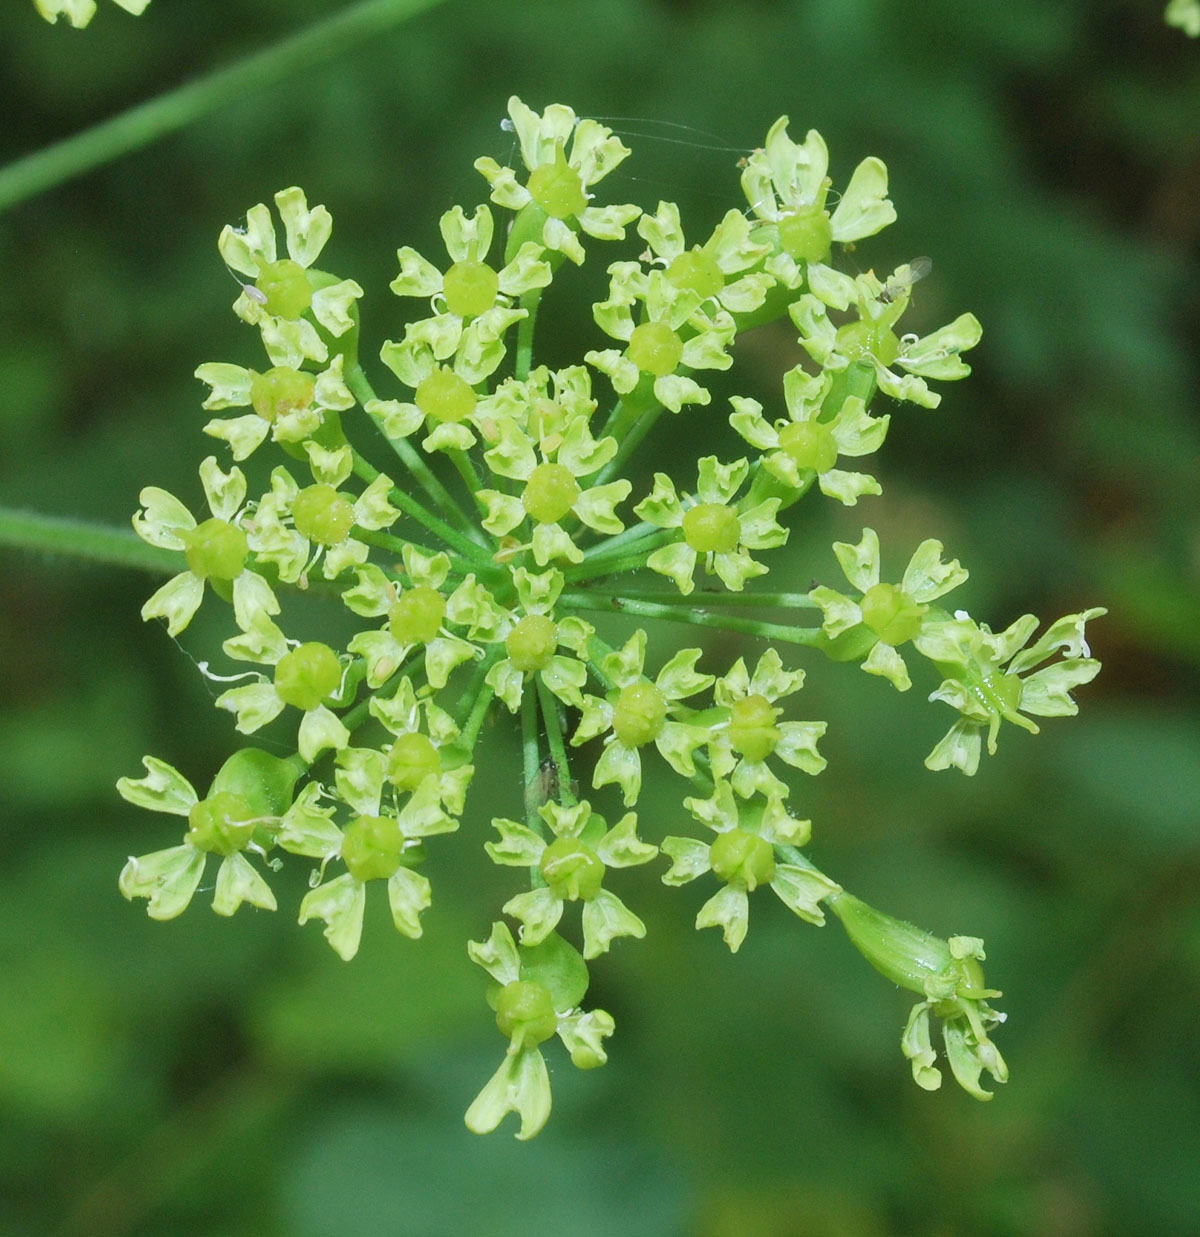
left=809, top=528, right=966, bottom=691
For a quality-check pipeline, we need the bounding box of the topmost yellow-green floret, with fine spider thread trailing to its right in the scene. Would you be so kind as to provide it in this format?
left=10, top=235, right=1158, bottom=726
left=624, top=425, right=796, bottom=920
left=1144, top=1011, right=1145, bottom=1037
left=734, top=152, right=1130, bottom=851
left=475, top=95, right=642, bottom=265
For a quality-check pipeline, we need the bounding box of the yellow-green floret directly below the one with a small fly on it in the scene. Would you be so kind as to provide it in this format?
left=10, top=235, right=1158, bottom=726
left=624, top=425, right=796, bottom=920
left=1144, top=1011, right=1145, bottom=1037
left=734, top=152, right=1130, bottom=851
left=729, top=366, right=891, bottom=507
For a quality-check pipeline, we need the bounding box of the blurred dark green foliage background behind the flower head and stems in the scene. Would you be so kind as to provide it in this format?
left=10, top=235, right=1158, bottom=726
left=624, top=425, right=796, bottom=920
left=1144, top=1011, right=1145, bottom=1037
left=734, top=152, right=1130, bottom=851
left=0, top=0, right=1200, bottom=1237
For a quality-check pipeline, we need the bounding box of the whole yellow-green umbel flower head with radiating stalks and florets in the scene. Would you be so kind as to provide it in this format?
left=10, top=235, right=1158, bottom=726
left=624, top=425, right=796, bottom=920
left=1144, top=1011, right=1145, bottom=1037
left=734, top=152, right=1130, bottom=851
left=118, top=99, right=1102, bottom=1138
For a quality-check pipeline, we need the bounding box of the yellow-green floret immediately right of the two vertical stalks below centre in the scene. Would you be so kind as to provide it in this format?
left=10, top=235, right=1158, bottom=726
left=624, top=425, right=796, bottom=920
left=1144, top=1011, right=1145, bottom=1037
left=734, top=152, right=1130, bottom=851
left=572, top=628, right=714, bottom=808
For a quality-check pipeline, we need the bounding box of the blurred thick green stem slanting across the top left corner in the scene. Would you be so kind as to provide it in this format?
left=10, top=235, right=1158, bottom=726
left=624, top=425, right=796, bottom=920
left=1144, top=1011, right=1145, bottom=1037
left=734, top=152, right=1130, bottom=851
left=0, top=0, right=450, bottom=210
